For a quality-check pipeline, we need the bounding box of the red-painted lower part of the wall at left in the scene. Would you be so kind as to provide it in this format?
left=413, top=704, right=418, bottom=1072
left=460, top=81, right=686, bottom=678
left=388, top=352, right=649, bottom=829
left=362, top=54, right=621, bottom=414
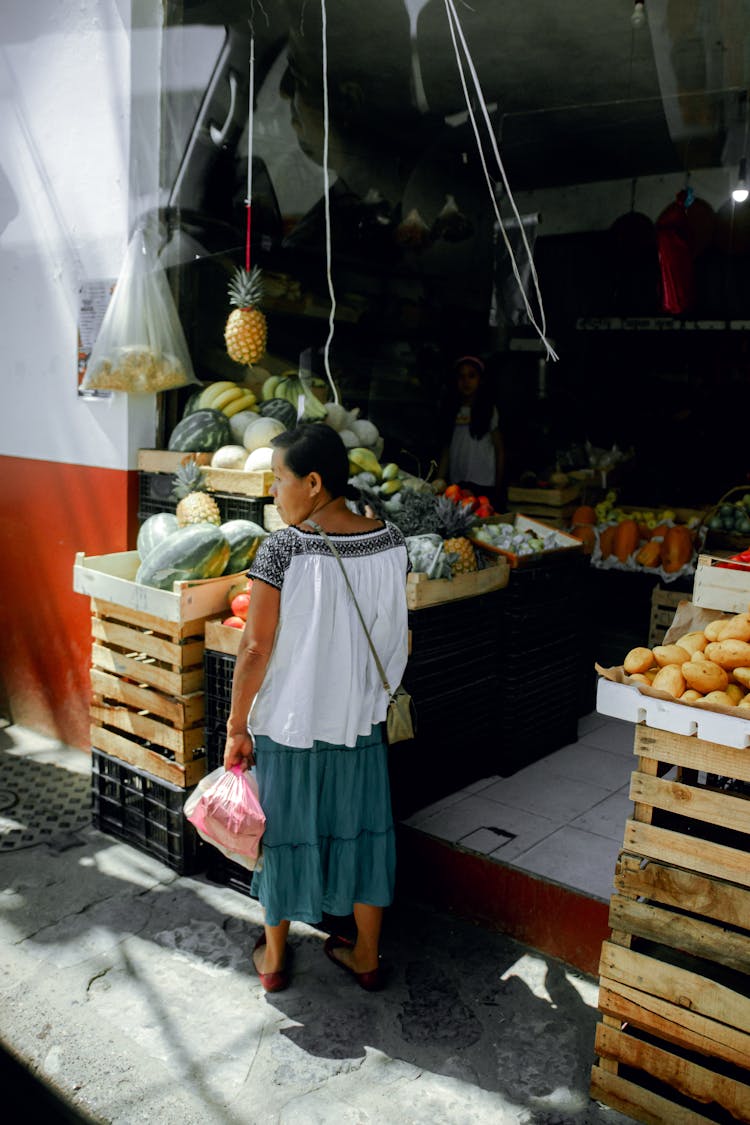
left=0, top=457, right=138, bottom=750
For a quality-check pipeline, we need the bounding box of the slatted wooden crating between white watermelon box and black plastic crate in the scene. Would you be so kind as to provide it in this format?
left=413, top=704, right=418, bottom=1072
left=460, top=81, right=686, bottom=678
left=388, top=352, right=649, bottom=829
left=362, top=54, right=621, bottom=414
left=90, top=599, right=206, bottom=788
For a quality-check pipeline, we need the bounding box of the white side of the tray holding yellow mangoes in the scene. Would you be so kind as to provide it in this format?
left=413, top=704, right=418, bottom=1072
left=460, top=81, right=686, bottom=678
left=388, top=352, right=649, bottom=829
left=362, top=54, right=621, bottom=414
left=596, top=676, right=750, bottom=750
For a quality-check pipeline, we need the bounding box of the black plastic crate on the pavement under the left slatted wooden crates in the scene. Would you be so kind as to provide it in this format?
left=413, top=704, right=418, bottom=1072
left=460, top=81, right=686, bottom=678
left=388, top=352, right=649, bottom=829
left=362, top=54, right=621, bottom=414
left=91, top=749, right=206, bottom=875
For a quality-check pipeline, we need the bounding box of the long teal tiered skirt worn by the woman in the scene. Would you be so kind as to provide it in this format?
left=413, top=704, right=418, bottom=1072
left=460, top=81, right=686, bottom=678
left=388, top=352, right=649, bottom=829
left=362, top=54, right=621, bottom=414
left=251, top=725, right=396, bottom=926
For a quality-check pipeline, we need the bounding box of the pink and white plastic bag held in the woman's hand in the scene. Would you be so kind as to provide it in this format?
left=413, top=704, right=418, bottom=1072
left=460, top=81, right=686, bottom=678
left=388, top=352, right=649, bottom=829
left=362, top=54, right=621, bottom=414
left=183, top=766, right=265, bottom=871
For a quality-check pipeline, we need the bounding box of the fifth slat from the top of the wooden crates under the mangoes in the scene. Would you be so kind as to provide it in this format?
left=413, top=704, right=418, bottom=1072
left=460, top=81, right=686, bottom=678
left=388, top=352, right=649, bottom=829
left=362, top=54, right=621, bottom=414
left=609, top=894, right=750, bottom=973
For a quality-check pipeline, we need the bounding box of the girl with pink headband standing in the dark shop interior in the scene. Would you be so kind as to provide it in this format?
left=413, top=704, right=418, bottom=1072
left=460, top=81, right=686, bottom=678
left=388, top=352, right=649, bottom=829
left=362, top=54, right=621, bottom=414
left=437, top=356, right=505, bottom=510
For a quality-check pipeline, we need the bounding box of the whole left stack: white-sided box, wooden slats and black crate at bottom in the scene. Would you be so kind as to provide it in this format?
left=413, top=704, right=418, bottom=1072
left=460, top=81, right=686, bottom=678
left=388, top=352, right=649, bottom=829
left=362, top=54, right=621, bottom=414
left=73, top=551, right=238, bottom=874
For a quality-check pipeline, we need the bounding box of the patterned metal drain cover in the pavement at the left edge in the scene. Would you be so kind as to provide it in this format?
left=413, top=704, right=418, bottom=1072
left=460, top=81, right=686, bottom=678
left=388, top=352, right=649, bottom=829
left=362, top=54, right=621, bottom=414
left=0, top=750, right=91, bottom=852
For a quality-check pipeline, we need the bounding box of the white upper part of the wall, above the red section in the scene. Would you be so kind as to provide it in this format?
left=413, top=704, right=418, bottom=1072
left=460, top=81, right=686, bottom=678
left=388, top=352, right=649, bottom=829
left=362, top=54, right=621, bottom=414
left=0, top=0, right=161, bottom=469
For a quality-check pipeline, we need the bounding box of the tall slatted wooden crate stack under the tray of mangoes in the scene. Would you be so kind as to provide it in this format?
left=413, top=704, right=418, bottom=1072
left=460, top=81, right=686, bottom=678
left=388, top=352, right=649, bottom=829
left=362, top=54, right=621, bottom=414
left=590, top=727, right=750, bottom=1125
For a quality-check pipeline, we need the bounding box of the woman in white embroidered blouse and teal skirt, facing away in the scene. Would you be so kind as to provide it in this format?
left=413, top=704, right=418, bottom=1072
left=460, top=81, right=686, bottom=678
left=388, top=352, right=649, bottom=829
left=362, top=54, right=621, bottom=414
left=224, top=423, right=408, bottom=991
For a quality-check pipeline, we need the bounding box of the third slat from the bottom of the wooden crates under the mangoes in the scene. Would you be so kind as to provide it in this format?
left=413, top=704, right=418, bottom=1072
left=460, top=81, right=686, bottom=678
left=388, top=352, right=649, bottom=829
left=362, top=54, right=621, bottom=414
left=598, top=978, right=750, bottom=1068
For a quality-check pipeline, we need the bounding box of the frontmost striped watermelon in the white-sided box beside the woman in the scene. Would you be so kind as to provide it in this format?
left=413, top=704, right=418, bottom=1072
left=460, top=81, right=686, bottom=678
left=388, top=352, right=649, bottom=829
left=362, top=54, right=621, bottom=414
left=135, top=523, right=231, bottom=590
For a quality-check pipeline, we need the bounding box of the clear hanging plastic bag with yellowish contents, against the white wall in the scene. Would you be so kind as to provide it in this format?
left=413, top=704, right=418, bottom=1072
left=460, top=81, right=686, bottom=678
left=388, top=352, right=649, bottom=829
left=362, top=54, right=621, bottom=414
left=81, top=227, right=199, bottom=395
